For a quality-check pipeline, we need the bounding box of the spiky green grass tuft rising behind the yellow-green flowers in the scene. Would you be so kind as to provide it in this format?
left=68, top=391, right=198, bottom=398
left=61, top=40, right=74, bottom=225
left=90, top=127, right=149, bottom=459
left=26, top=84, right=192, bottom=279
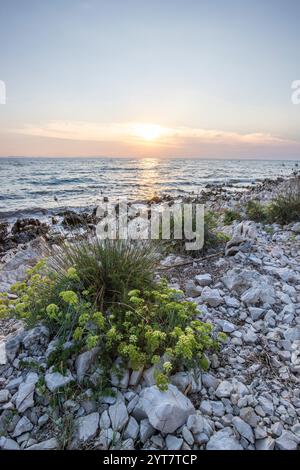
left=50, top=239, right=158, bottom=309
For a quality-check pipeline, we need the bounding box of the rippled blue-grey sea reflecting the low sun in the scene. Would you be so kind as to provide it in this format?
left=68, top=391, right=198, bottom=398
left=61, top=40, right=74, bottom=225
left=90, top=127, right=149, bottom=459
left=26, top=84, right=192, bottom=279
left=0, top=158, right=297, bottom=216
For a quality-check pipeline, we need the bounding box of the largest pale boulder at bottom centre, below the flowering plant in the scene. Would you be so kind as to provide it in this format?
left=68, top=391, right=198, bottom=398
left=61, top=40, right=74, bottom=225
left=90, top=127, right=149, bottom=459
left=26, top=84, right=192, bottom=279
left=140, top=384, right=195, bottom=434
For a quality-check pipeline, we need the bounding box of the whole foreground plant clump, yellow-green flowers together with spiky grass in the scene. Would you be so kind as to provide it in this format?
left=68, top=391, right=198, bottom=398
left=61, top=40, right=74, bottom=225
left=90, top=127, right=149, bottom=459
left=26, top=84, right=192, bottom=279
left=0, top=240, right=220, bottom=389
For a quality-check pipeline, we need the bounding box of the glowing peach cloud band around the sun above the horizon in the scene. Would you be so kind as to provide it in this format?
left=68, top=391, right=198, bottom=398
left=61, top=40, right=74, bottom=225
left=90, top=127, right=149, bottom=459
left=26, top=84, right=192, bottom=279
left=7, top=121, right=300, bottom=158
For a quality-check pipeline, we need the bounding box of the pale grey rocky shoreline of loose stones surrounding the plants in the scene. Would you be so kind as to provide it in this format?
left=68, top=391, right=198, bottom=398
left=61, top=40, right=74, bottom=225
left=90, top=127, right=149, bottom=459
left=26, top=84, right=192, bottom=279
left=0, top=173, right=300, bottom=450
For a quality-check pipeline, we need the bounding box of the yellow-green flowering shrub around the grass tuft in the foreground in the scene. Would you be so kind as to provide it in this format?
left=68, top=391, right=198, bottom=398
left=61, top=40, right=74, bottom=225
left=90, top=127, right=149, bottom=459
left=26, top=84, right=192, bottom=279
left=1, top=245, right=219, bottom=389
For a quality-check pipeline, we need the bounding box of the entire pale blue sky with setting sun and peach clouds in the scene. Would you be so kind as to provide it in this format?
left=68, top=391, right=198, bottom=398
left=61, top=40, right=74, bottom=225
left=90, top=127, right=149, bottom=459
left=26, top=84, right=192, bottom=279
left=0, top=0, right=300, bottom=159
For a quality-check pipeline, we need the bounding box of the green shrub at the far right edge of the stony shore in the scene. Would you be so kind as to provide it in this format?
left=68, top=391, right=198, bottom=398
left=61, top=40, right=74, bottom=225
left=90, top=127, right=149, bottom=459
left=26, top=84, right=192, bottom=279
left=268, top=178, right=300, bottom=225
